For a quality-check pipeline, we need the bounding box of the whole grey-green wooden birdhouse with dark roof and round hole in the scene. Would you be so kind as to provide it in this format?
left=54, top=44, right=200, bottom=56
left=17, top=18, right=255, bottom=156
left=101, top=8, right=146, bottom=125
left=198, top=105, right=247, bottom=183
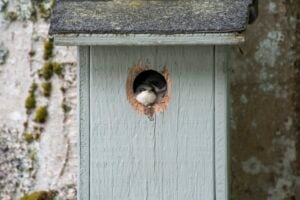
left=50, top=0, right=256, bottom=200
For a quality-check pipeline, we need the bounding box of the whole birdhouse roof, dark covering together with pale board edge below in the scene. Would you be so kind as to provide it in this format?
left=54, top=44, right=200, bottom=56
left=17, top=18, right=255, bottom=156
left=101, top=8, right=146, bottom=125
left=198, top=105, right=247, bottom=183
left=49, top=0, right=252, bottom=45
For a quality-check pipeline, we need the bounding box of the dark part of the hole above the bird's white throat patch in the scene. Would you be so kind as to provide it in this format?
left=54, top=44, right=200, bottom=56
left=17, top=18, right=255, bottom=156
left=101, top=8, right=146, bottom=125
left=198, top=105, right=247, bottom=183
left=133, top=70, right=167, bottom=100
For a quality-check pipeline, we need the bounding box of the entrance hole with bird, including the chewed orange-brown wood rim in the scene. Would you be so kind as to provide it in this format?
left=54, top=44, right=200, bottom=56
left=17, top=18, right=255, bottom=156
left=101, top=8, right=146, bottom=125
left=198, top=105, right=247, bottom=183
left=126, top=64, right=171, bottom=117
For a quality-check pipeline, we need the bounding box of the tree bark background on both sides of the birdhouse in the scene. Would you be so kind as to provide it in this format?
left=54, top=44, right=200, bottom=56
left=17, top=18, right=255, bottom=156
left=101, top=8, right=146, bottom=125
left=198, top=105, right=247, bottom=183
left=0, top=0, right=300, bottom=200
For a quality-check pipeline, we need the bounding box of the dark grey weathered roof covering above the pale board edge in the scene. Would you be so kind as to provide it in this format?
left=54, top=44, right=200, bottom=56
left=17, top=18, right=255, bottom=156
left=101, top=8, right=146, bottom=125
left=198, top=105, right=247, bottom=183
left=50, top=0, right=252, bottom=35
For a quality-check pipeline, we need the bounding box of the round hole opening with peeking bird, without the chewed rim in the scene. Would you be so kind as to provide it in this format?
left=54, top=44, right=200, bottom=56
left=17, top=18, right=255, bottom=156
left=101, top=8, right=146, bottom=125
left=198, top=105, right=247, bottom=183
left=133, top=70, right=167, bottom=107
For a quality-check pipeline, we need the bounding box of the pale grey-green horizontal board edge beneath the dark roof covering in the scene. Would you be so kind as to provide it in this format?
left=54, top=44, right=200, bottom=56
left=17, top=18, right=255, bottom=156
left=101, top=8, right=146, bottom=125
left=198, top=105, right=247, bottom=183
left=54, top=33, right=245, bottom=46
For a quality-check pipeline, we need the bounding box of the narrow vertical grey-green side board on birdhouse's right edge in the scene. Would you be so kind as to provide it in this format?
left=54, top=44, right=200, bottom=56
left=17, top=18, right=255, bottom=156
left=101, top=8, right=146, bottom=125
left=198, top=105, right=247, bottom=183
left=215, top=46, right=229, bottom=200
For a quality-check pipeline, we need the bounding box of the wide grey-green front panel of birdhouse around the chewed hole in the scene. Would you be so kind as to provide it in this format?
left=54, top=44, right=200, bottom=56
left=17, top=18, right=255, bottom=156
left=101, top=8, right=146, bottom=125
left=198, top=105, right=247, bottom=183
left=90, top=46, right=215, bottom=200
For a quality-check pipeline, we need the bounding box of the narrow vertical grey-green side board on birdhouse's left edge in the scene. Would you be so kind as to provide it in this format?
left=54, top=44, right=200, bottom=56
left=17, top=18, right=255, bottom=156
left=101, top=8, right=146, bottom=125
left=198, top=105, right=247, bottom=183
left=77, top=46, right=90, bottom=200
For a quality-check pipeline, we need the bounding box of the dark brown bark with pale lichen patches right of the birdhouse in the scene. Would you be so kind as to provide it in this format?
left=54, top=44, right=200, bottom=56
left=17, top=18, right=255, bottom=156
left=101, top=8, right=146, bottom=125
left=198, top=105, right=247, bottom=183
left=231, top=0, right=300, bottom=200
